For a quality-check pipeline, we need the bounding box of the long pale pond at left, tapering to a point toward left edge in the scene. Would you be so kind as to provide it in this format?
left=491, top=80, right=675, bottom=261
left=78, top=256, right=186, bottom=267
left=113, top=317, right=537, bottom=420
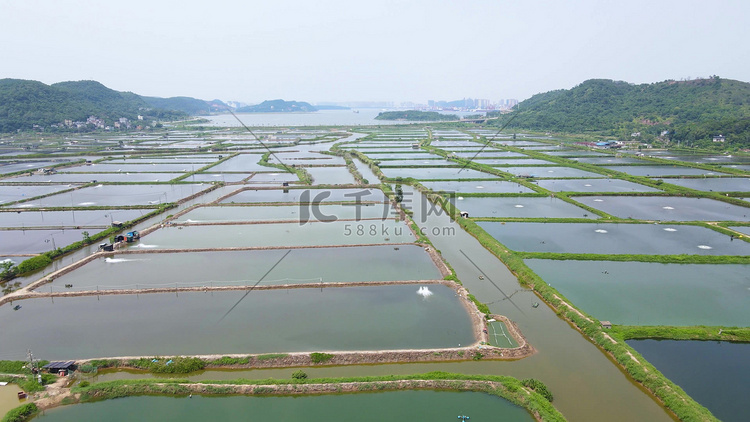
left=9, top=183, right=210, bottom=208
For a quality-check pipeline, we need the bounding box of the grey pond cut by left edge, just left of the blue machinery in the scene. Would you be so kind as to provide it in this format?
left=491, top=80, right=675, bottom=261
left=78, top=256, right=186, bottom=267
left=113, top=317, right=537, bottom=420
left=0, top=229, right=89, bottom=255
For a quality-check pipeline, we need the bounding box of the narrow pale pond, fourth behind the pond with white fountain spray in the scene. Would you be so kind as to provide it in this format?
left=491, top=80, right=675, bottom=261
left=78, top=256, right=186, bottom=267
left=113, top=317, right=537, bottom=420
left=221, top=188, right=388, bottom=204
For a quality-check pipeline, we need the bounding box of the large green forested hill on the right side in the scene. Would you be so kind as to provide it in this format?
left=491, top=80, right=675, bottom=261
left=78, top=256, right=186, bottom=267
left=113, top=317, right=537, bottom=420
left=497, top=77, right=750, bottom=147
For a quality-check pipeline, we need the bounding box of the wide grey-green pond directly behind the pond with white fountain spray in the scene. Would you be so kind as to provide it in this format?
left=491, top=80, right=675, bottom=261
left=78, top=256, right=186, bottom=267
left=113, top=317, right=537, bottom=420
left=50, top=245, right=443, bottom=291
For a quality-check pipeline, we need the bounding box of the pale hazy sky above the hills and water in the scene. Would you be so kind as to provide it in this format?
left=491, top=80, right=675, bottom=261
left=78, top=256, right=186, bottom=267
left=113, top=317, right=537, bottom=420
left=0, top=0, right=750, bottom=102
